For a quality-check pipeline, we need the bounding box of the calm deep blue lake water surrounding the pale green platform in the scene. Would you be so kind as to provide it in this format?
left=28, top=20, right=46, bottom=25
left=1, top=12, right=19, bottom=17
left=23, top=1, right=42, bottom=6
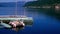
left=0, top=7, right=60, bottom=34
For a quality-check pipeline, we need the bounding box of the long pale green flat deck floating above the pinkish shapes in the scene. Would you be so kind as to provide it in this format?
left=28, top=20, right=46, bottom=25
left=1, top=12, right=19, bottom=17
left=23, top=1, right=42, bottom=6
left=0, top=15, right=33, bottom=25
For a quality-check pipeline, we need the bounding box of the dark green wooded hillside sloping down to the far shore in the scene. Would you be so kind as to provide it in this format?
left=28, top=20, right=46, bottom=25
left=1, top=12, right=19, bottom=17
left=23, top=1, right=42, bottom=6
left=25, top=0, right=60, bottom=6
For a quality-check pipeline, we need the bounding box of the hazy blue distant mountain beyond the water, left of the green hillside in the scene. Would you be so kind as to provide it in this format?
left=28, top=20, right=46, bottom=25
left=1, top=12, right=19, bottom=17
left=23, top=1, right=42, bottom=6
left=0, top=2, right=25, bottom=7
